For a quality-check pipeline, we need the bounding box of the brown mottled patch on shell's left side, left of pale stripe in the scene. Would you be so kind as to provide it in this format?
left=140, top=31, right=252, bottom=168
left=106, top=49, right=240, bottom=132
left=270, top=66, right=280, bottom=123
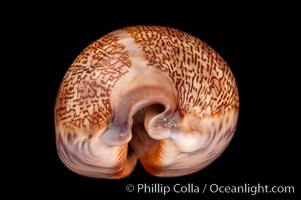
left=55, top=34, right=131, bottom=132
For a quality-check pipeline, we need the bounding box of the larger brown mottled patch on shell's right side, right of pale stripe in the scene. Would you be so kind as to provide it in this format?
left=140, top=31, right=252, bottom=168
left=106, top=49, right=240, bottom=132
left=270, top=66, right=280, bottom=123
left=124, top=26, right=239, bottom=115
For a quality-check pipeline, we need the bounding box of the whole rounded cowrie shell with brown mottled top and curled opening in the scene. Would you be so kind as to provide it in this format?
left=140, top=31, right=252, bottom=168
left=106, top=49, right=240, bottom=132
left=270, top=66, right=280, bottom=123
left=55, top=26, right=239, bottom=179
